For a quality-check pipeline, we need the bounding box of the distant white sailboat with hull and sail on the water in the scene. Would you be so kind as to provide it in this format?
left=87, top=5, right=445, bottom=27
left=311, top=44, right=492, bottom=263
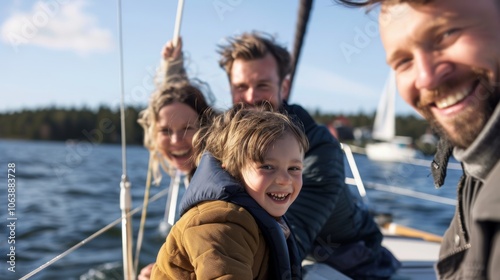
left=366, top=70, right=418, bottom=162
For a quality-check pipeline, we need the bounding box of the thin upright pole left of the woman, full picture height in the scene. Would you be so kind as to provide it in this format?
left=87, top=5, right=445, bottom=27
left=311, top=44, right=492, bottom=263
left=118, top=0, right=135, bottom=280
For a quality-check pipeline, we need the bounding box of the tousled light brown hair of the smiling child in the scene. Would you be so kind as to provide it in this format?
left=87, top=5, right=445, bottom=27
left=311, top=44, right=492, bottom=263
left=193, top=104, right=309, bottom=180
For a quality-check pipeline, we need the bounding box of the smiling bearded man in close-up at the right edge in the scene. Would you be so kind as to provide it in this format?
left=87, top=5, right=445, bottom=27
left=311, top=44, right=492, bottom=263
left=339, top=0, right=500, bottom=279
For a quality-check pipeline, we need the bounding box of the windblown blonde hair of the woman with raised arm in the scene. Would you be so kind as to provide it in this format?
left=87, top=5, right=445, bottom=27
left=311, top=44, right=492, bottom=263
left=137, top=80, right=216, bottom=184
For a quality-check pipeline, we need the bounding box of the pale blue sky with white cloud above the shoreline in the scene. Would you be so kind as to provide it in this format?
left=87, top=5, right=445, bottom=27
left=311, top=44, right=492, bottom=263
left=0, top=0, right=413, bottom=114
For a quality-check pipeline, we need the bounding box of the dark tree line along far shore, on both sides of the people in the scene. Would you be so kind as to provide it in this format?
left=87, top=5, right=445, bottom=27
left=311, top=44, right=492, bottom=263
left=0, top=106, right=428, bottom=145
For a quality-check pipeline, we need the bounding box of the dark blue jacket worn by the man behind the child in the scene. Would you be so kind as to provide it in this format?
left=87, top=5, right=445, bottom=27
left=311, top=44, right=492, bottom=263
left=283, top=103, right=400, bottom=279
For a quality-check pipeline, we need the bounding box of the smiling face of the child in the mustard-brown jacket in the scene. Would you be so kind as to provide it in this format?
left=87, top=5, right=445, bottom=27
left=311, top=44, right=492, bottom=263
left=241, top=133, right=304, bottom=217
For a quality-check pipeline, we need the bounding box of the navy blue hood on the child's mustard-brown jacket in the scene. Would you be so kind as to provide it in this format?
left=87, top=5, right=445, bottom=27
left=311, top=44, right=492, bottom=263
left=180, top=152, right=245, bottom=215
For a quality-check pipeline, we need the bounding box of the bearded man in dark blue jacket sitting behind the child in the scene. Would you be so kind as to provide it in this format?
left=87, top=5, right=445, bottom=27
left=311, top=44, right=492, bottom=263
left=219, top=33, right=399, bottom=279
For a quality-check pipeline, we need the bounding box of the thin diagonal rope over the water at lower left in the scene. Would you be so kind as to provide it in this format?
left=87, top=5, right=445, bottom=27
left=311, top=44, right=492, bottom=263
left=19, top=186, right=172, bottom=280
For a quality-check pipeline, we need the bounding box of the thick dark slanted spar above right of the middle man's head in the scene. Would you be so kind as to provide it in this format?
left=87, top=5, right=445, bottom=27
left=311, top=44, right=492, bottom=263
left=287, top=0, right=313, bottom=101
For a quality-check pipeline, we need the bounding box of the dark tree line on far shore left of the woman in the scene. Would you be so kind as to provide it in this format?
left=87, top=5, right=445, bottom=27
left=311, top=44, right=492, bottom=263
left=0, top=106, right=143, bottom=145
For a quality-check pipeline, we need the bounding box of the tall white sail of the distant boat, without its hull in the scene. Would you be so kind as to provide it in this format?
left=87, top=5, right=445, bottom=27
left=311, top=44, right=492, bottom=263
left=372, top=70, right=397, bottom=141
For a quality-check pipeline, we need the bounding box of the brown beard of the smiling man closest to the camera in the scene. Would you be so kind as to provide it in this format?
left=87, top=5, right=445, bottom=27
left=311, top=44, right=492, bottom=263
left=419, top=78, right=500, bottom=149
